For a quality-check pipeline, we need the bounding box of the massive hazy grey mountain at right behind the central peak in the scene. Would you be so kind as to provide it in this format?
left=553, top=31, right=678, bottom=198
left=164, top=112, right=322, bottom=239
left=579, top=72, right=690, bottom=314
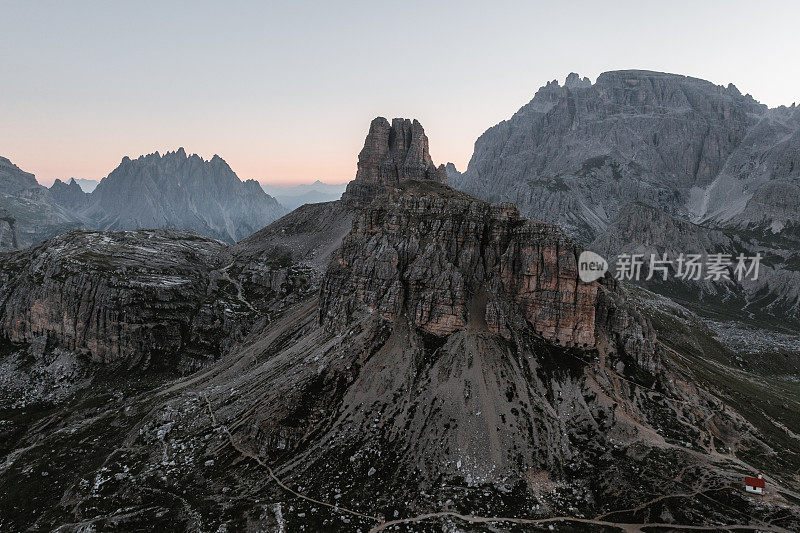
left=453, top=71, right=800, bottom=243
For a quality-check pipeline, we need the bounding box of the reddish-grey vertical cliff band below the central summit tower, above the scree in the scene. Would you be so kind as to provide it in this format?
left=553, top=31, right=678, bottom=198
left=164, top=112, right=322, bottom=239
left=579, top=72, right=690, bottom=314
left=320, top=182, right=653, bottom=358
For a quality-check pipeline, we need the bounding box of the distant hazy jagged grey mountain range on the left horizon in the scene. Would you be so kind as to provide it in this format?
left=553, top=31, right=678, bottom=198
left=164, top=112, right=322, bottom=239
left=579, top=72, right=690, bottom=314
left=0, top=148, right=287, bottom=250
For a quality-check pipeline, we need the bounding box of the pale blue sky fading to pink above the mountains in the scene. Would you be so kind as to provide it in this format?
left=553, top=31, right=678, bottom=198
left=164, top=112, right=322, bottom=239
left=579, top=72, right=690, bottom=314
left=0, top=0, right=800, bottom=185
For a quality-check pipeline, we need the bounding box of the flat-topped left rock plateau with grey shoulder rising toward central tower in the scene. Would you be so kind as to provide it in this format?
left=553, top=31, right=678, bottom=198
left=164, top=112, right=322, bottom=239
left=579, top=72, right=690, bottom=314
left=0, top=203, right=349, bottom=371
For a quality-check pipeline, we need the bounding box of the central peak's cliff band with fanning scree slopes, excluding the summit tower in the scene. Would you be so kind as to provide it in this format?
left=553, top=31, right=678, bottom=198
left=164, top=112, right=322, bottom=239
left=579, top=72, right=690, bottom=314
left=236, top=180, right=744, bottom=497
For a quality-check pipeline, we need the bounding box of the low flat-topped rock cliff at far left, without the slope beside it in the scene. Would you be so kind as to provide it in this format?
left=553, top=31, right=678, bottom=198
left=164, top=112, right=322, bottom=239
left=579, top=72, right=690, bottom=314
left=0, top=232, right=231, bottom=367
